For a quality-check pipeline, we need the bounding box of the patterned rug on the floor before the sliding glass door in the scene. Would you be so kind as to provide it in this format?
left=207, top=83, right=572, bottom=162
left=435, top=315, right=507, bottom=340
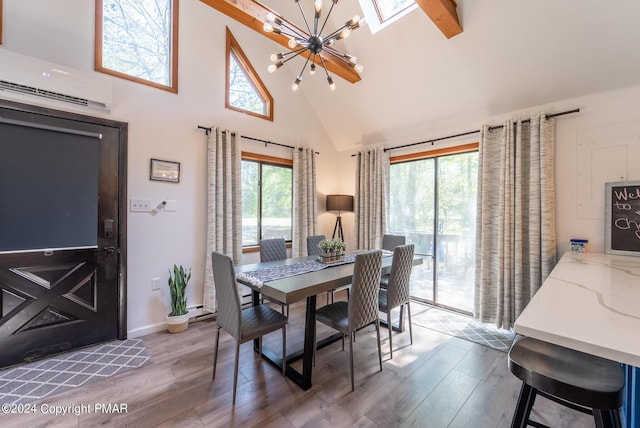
left=413, top=308, right=515, bottom=352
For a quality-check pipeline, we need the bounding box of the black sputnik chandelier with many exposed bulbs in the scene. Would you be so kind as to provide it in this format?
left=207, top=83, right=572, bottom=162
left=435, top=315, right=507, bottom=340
left=263, top=0, right=365, bottom=91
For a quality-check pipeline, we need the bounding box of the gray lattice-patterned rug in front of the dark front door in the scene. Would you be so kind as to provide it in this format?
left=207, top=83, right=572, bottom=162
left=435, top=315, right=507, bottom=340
left=0, top=339, right=151, bottom=405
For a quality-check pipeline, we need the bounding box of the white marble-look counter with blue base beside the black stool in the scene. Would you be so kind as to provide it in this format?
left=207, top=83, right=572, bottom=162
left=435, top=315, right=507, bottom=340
left=514, top=252, right=640, bottom=428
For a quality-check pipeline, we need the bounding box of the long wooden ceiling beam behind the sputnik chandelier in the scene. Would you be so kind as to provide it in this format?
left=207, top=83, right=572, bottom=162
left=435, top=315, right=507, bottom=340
left=200, top=0, right=360, bottom=83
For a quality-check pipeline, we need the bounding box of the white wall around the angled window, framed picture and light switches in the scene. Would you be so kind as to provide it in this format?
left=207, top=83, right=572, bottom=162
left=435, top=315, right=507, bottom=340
left=2, top=0, right=350, bottom=337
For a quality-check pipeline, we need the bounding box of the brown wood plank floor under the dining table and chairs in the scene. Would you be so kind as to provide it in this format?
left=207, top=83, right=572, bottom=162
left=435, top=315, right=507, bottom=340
left=0, top=297, right=594, bottom=428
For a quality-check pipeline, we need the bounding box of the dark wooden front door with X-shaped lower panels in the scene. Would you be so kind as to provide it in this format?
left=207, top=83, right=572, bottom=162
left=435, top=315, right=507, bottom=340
left=0, top=101, right=126, bottom=367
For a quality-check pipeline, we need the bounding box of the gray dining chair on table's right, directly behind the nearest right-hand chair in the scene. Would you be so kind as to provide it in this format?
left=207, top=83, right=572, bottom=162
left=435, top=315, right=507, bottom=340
left=378, top=244, right=414, bottom=358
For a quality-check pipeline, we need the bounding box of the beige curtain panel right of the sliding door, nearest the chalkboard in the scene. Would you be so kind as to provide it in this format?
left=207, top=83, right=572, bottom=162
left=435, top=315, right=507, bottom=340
left=474, top=114, right=556, bottom=329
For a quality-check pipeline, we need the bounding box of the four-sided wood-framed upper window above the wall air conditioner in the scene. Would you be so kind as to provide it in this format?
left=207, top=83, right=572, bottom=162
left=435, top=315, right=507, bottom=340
left=95, top=0, right=179, bottom=93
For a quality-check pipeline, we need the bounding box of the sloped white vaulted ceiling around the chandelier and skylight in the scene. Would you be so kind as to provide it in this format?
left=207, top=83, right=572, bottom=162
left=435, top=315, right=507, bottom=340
left=216, top=0, right=640, bottom=150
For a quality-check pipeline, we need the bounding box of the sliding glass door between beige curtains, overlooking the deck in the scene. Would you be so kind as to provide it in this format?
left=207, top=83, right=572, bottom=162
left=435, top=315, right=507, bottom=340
left=387, top=151, right=478, bottom=313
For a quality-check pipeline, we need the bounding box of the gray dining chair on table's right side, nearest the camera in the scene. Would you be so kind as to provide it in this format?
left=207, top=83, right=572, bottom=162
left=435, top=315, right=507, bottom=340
left=314, top=250, right=382, bottom=391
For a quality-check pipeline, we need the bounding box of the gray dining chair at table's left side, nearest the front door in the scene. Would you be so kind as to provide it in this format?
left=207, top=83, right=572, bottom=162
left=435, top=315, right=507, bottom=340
left=211, top=252, right=287, bottom=404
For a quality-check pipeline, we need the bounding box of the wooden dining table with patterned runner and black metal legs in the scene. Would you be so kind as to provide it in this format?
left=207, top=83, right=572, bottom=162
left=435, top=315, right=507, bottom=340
left=234, top=251, right=422, bottom=390
